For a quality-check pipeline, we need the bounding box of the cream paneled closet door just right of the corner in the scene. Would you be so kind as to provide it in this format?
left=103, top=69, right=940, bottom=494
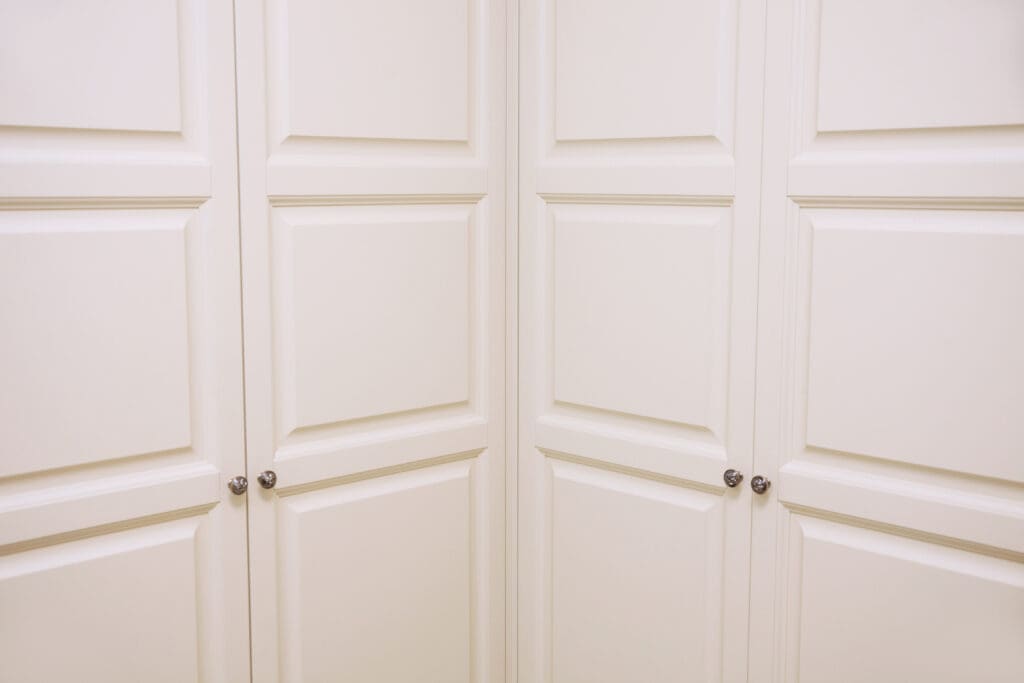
left=519, top=0, right=764, bottom=683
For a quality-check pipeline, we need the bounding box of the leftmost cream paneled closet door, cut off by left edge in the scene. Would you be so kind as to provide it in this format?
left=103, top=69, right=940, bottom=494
left=0, top=0, right=249, bottom=683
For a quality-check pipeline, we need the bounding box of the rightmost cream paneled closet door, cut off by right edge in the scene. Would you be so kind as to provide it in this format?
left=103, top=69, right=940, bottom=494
left=751, top=0, right=1024, bottom=683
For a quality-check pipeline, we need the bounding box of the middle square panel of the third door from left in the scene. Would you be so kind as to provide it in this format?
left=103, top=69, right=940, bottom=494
left=552, top=206, right=729, bottom=426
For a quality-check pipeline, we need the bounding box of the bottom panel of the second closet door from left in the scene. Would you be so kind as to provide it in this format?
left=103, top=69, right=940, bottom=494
left=279, top=462, right=471, bottom=683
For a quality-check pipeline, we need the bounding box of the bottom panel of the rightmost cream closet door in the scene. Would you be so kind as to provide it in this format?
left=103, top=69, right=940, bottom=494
left=794, top=518, right=1024, bottom=683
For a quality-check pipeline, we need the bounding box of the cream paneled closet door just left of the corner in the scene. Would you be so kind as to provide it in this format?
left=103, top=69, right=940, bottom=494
left=237, top=0, right=506, bottom=683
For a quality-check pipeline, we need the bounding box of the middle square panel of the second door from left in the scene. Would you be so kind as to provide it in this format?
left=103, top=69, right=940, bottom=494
left=274, top=206, right=472, bottom=429
